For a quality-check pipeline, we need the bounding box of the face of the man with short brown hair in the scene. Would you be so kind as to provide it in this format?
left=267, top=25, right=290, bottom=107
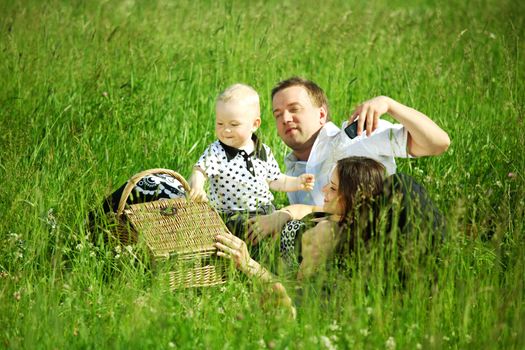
left=272, top=86, right=326, bottom=152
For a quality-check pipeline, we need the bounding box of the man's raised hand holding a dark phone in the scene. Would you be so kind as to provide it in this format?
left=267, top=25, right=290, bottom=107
left=348, top=96, right=390, bottom=136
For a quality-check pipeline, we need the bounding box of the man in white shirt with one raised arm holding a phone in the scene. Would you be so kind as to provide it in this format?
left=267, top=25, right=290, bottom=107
left=248, top=77, right=450, bottom=242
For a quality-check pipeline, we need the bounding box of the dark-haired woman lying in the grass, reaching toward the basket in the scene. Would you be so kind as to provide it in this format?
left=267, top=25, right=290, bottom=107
left=215, top=157, right=443, bottom=313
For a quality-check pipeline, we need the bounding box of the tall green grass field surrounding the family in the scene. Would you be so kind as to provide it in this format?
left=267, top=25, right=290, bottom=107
left=0, top=0, right=525, bottom=349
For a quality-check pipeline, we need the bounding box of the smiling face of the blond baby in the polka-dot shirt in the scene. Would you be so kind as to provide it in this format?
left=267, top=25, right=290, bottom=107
left=215, top=102, right=261, bottom=148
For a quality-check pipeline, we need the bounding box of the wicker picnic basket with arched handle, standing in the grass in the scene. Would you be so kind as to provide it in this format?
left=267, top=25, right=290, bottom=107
left=115, top=169, right=228, bottom=289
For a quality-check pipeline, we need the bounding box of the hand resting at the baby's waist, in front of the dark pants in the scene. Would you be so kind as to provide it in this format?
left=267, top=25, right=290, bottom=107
left=246, top=210, right=292, bottom=245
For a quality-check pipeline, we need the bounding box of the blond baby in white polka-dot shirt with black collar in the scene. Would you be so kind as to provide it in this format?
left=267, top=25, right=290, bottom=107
left=189, top=84, right=314, bottom=234
